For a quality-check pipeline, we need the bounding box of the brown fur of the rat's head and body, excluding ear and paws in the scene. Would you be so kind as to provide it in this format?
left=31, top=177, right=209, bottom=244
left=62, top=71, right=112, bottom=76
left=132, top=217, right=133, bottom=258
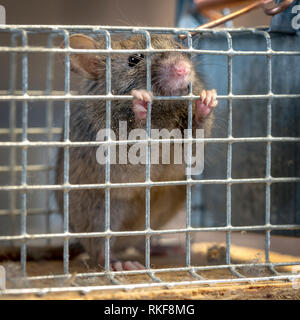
left=57, top=35, right=213, bottom=264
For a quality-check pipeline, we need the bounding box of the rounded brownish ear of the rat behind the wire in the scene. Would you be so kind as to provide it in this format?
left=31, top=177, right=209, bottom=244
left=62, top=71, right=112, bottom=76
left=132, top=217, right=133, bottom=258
left=61, top=34, right=102, bottom=80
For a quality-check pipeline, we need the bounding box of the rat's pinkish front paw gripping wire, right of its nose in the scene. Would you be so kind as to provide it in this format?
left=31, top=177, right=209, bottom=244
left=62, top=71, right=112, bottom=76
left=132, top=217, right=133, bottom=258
left=195, top=89, right=218, bottom=122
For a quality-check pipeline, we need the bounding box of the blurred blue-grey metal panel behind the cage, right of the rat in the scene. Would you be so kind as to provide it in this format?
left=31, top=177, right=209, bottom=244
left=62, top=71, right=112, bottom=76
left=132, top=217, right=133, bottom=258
left=176, top=0, right=300, bottom=236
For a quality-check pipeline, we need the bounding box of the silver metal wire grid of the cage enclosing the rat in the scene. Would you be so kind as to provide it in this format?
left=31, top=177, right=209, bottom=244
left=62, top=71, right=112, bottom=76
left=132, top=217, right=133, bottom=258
left=0, top=25, right=300, bottom=294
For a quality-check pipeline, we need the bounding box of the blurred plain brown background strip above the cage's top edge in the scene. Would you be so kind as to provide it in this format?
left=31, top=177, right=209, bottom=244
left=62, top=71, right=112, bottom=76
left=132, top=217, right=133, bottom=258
left=0, top=0, right=270, bottom=27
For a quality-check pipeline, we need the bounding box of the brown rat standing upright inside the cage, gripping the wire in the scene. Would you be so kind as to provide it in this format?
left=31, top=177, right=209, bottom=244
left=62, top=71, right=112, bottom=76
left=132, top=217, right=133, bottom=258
left=57, top=34, right=218, bottom=271
